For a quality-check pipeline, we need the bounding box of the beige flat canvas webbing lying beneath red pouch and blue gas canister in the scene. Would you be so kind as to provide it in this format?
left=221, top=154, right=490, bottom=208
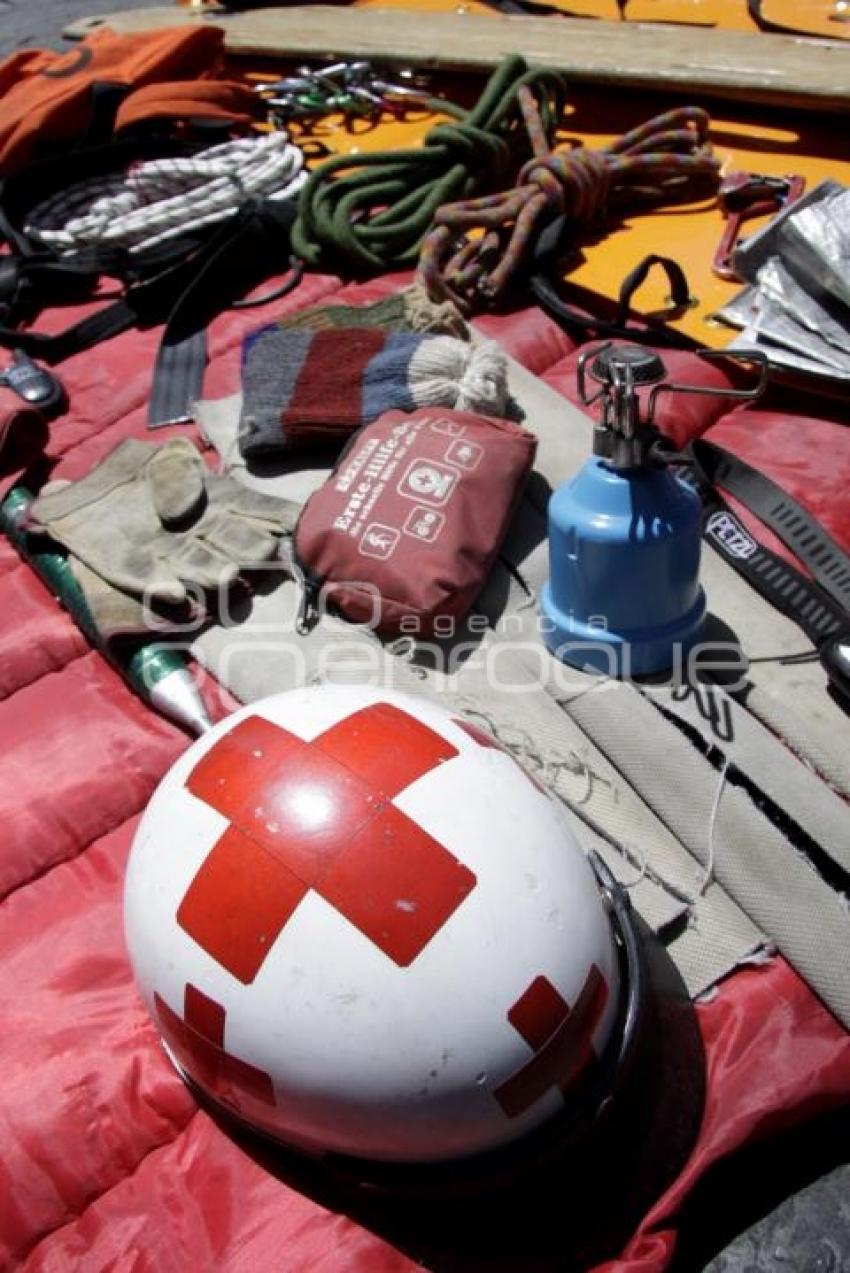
left=192, top=362, right=850, bottom=1026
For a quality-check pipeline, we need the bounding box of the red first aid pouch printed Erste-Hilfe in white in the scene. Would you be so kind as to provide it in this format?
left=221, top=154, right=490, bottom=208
left=294, top=407, right=537, bottom=637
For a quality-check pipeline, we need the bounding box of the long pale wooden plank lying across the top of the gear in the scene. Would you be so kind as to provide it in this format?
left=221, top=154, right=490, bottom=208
left=65, top=5, right=850, bottom=112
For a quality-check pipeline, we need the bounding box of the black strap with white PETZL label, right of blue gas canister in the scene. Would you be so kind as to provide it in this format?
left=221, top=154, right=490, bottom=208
left=682, top=439, right=850, bottom=647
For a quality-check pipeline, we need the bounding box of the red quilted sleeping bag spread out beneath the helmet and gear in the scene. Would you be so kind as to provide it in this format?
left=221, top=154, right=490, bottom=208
left=0, top=266, right=850, bottom=1273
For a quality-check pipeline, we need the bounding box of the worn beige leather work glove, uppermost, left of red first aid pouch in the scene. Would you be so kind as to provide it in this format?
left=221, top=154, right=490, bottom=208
left=31, top=438, right=299, bottom=635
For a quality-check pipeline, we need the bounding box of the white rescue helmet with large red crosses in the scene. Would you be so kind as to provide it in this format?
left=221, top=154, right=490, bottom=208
left=125, top=686, right=627, bottom=1164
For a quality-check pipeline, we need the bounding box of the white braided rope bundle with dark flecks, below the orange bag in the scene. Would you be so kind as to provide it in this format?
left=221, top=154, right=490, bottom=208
left=24, top=132, right=307, bottom=252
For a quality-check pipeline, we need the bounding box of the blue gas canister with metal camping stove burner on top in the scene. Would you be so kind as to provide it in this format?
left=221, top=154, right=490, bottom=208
left=541, top=344, right=763, bottom=677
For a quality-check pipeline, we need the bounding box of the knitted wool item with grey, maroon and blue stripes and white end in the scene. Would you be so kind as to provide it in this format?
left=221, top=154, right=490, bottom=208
left=239, top=325, right=508, bottom=457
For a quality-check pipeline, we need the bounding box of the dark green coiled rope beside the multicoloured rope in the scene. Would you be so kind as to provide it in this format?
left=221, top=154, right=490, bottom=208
left=291, top=55, right=566, bottom=274
